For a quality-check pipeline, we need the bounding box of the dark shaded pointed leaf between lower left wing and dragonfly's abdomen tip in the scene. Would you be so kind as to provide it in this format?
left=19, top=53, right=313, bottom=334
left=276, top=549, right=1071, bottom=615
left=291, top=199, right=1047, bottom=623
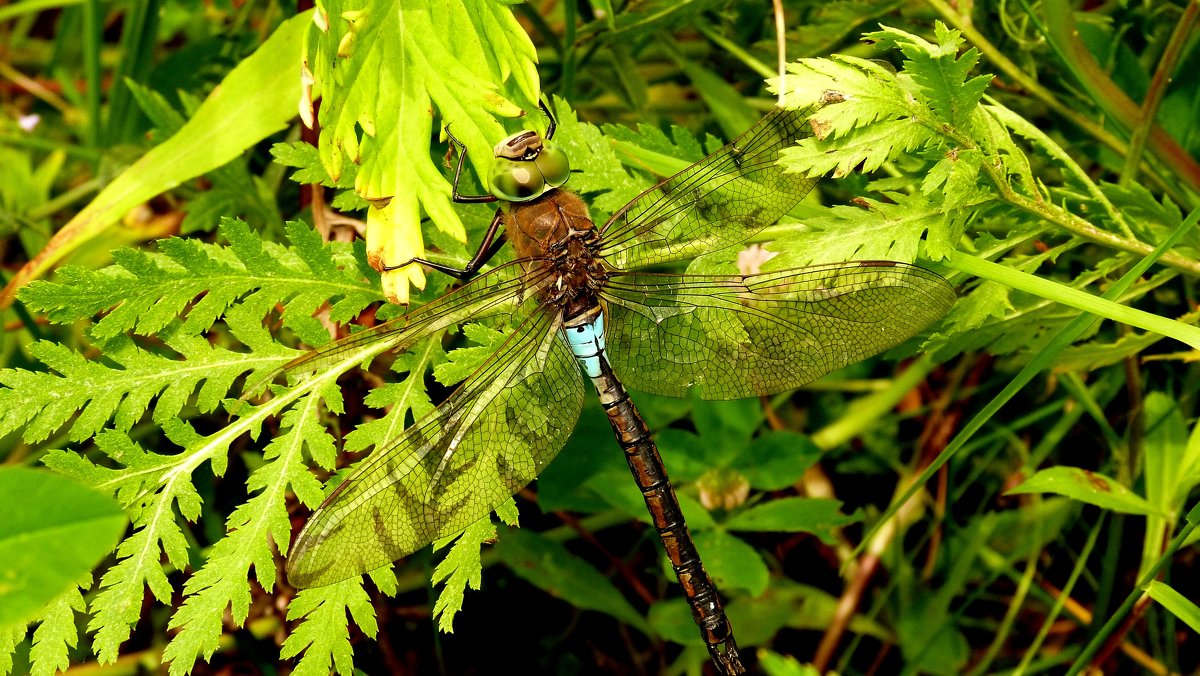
left=496, top=530, right=653, bottom=635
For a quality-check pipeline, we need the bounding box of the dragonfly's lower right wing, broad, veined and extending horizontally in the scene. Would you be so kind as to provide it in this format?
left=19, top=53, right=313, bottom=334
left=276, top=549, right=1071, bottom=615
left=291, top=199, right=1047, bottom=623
left=601, top=261, right=955, bottom=399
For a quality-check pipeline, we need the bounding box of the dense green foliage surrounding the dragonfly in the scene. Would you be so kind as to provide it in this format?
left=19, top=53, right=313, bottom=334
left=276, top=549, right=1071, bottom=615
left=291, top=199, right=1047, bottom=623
left=0, top=0, right=1200, bottom=674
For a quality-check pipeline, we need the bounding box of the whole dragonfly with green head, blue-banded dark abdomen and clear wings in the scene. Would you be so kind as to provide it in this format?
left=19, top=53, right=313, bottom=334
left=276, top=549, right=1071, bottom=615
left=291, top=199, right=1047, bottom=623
left=274, top=103, right=955, bottom=674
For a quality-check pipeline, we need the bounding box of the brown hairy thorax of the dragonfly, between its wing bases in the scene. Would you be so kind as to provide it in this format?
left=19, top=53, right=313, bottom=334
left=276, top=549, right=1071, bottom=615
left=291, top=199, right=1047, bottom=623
left=504, top=190, right=607, bottom=318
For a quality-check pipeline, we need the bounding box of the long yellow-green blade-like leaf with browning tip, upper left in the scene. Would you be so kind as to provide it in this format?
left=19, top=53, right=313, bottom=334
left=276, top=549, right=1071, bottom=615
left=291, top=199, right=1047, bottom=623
left=0, top=12, right=312, bottom=307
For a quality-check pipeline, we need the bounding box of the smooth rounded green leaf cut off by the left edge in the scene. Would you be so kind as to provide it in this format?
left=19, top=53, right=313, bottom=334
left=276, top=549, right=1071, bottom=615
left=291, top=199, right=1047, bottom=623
left=0, top=467, right=128, bottom=627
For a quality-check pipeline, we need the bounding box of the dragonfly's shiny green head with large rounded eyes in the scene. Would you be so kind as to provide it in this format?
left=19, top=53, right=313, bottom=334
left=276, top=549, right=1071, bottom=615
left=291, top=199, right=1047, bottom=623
left=491, top=131, right=571, bottom=202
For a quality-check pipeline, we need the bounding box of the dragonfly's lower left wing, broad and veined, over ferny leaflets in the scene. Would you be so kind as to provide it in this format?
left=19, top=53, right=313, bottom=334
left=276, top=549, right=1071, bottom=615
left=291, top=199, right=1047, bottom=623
left=280, top=303, right=583, bottom=588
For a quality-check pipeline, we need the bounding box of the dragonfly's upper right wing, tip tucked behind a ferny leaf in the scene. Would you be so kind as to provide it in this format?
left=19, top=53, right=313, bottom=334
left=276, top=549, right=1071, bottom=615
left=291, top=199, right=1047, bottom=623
left=600, top=108, right=816, bottom=270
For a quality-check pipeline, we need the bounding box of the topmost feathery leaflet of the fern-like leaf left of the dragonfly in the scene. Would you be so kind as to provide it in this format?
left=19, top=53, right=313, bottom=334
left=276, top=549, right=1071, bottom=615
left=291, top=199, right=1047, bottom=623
left=20, top=219, right=380, bottom=345
